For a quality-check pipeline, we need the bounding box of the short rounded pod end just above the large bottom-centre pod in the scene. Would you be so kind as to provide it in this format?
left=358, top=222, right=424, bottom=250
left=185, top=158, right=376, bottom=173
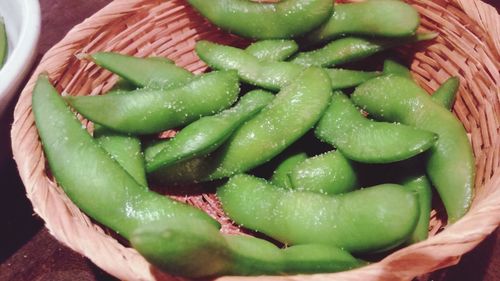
left=290, top=151, right=358, bottom=195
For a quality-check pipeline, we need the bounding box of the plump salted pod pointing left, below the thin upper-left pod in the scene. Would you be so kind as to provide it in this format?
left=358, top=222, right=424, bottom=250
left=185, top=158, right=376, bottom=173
left=66, top=71, right=239, bottom=134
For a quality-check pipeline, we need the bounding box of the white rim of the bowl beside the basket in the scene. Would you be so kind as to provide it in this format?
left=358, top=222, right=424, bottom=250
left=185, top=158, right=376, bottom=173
left=0, top=0, right=41, bottom=114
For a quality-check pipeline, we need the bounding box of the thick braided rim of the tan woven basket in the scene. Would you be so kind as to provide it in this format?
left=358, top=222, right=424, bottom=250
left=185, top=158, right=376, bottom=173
left=11, top=0, right=500, bottom=280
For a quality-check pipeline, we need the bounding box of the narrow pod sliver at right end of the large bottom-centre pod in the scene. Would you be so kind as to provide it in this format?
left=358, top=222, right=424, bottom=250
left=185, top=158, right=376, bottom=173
left=402, top=175, right=432, bottom=244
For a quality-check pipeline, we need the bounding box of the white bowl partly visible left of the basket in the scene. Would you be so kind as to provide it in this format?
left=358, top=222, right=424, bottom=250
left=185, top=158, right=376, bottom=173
left=0, top=0, right=41, bottom=116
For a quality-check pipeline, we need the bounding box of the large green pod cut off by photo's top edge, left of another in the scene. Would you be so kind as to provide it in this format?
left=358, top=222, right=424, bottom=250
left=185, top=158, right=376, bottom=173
left=188, top=0, right=333, bottom=39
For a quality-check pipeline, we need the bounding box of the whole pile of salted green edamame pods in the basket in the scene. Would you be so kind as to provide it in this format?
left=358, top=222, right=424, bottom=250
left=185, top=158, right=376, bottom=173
left=32, top=0, right=475, bottom=278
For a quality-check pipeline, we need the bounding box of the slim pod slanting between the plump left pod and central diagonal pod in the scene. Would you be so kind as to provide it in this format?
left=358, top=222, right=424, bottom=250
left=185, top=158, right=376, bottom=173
left=144, top=90, right=274, bottom=172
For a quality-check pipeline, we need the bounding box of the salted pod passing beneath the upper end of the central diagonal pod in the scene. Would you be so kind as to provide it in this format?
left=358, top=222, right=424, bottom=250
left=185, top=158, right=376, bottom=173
left=196, top=41, right=378, bottom=91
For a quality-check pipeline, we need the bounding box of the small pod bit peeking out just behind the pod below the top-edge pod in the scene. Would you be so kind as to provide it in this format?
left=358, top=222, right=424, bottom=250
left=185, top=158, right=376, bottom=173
left=245, top=39, right=299, bottom=61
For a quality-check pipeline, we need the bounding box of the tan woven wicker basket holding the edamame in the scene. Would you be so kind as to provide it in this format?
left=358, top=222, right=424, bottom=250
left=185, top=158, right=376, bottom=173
left=8, top=0, right=500, bottom=280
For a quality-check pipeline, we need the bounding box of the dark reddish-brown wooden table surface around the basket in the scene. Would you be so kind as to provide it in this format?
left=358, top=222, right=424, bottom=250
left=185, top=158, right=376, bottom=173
left=0, top=0, right=500, bottom=281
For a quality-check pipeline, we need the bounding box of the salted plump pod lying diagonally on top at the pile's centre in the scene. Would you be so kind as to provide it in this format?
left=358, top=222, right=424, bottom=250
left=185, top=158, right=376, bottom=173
left=210, top=68, right=331, bottom=179
